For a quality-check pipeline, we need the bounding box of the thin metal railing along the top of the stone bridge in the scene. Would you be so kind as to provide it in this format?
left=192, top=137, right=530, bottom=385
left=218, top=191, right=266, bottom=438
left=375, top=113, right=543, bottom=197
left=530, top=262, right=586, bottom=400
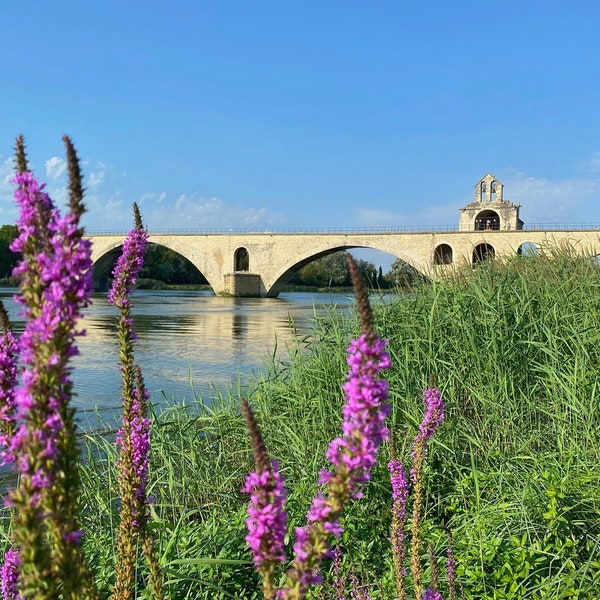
left=86, top=222, right=600, bottom=236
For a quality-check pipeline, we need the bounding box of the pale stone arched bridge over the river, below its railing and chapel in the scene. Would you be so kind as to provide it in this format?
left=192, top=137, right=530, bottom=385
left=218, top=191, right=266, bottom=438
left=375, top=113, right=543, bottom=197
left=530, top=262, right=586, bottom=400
left=88, top=229, right=600, bottom=297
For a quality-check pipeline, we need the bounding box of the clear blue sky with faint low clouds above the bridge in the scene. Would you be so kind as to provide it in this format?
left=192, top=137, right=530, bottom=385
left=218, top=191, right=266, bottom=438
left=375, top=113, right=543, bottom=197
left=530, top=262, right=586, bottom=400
left=0, top=0, right=600, bottom=268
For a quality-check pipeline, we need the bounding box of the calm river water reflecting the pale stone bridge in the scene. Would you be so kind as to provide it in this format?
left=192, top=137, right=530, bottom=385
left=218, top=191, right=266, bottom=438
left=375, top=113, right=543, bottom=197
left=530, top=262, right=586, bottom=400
left=0, top=288, right=353, bottom=427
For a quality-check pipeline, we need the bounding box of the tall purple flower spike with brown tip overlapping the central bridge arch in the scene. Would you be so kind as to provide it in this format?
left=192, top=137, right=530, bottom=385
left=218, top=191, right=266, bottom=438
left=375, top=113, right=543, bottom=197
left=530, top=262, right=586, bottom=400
left=279, top=256, right=391, bottom=598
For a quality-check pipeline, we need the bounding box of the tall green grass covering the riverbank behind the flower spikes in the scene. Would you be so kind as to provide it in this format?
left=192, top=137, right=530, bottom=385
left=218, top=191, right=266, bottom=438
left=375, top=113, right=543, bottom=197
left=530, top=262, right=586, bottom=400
left=17, top=253, right=600, bottom=600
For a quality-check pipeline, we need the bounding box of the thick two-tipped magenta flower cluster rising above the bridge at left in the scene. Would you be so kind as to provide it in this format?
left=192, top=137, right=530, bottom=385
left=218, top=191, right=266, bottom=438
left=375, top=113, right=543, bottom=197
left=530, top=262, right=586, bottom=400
left=6, top=137, right=93, bottom=597
